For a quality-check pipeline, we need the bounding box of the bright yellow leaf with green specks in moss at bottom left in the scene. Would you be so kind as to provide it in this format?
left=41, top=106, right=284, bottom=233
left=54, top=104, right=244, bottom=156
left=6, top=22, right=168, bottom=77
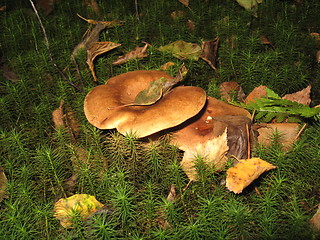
left=53, top=194, right=104, bottom=228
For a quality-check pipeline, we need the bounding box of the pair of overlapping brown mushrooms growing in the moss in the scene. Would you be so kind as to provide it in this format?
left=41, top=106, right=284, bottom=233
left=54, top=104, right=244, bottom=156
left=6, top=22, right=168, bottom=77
left=84, top=70, right=251, bottom=178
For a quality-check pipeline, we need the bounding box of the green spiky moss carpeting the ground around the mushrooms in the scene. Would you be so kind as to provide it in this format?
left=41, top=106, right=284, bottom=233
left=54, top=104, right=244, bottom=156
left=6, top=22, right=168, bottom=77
left=0, top=0, right=320, bottom=239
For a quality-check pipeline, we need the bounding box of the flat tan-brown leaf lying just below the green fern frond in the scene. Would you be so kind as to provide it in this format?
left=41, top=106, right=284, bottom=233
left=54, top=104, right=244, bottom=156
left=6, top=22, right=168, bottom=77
left=254, top=123, right=300, bottom=150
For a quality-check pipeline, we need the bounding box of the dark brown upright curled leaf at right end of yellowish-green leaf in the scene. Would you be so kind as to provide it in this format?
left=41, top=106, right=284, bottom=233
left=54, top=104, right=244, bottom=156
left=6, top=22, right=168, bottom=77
left=200, top=37, right=220, bottom=71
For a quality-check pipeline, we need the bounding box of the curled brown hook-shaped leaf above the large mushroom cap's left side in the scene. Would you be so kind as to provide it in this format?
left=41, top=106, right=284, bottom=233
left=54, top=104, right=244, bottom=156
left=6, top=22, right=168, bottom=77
left=87, top=42, right=121, bottom=82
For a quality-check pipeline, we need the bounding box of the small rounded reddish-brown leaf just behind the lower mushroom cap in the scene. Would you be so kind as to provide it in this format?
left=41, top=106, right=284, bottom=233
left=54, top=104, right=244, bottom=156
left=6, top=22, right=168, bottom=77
left=219, top=82, right=245, bottom=102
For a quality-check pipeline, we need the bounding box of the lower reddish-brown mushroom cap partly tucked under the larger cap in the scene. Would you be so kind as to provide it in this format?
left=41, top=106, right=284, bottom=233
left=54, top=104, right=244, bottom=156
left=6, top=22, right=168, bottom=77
left=172, top=97, right=251, bottom=156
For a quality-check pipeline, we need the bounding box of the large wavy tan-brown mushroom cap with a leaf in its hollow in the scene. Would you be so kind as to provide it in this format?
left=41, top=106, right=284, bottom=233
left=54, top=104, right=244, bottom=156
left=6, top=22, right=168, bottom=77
left=84, top=70, right=206, bottom=137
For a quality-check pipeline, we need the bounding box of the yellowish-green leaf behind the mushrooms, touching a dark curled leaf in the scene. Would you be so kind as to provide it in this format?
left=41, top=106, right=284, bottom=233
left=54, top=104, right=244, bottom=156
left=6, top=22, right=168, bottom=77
left=158, top=40, right=202, bottom=61
